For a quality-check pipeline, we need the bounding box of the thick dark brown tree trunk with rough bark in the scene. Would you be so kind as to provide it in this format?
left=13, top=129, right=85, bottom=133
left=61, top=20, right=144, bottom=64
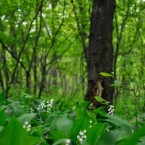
left=85, top=0, right=116, bottom=107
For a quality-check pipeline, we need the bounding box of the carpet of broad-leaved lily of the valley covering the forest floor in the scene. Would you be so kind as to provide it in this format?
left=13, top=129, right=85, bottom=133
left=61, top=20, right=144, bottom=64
left=0, top=94, right=145, bottom=145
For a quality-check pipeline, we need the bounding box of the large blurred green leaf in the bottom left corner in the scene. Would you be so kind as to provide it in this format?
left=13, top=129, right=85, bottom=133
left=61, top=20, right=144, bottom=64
left=0, top=118, right=44, bottom=145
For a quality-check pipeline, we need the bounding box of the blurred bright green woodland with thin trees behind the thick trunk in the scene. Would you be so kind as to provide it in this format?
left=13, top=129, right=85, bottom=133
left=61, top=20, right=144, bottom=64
left=0, top=0, right=145, bottom=117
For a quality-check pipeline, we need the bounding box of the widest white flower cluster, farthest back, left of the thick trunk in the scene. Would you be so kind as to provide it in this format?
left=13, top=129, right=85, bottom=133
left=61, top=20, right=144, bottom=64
left=38, top=99, right=54, bottom=111
